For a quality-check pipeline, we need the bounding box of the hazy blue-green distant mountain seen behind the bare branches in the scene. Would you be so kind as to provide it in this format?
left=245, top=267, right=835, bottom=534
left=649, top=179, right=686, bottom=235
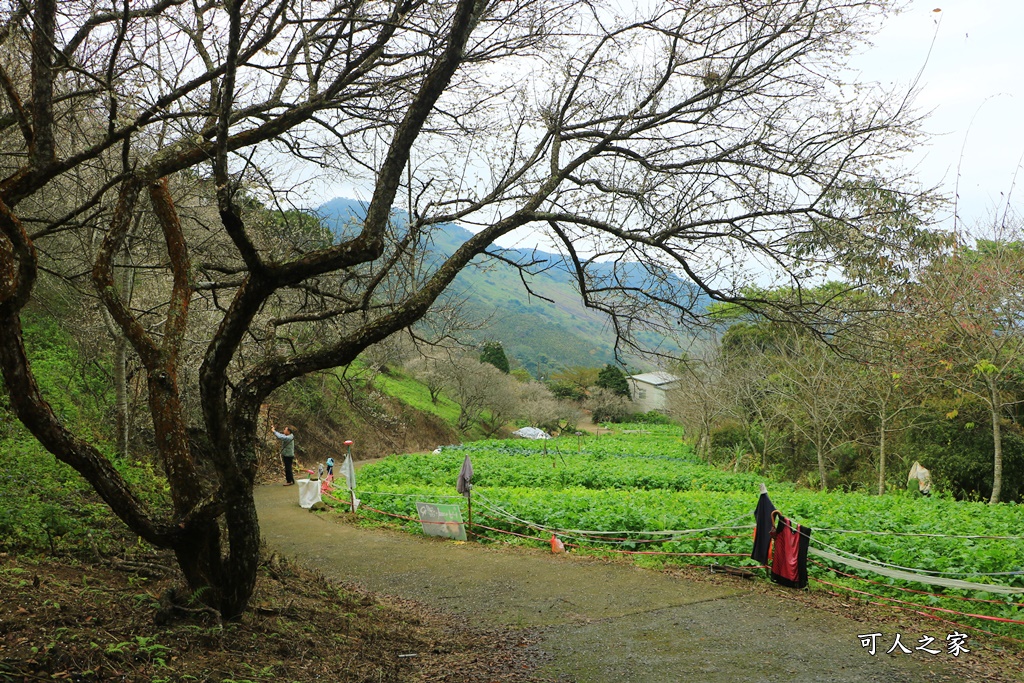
left=317, top=198, right=692, bottom=377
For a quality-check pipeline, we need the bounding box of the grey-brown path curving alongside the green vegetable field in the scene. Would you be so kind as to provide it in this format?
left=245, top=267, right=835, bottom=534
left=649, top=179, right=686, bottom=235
left=256, top=485, right=999, bottom=683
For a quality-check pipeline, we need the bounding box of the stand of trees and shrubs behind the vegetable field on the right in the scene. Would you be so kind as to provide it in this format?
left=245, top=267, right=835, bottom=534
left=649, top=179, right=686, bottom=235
left=671, top=253, right=1024, bottom=503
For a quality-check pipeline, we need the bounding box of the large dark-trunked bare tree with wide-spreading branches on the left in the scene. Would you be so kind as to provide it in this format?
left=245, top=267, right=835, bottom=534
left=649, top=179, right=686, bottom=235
left=0, top=0, right=913, bottom=616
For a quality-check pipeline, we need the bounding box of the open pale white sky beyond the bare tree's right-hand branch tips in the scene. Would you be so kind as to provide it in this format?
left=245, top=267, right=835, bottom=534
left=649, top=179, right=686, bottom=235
left=854, top=0, right=1024, bottom=229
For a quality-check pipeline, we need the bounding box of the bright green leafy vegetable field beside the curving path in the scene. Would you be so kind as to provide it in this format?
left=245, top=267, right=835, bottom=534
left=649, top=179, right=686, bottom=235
left=342, top=425, right=1024, bottom=644
